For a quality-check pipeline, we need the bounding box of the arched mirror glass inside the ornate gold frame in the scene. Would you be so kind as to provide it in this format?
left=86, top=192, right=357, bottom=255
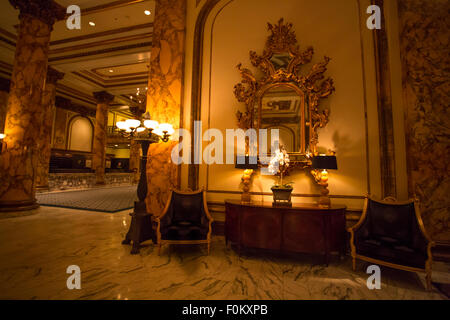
left=255, top=86, right=309, bottom=153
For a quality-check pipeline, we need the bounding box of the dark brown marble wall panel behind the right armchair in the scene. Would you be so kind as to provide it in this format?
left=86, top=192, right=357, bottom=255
left=398, top=0, right=450, bottom=241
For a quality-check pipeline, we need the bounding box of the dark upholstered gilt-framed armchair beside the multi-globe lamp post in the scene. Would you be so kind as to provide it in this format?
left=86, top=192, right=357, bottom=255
left=156, top=190, right=213, bottom=254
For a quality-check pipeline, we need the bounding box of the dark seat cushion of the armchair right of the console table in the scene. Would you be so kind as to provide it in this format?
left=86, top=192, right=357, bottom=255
left=356, top=237, right=427, bottom=269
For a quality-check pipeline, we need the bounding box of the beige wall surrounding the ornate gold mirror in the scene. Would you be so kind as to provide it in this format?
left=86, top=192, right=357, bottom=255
left=182, top=0, right=381, bottom=208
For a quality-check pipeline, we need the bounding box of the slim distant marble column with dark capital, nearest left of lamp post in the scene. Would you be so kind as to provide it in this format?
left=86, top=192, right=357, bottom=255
left=92, top=91, right=114, bottom=185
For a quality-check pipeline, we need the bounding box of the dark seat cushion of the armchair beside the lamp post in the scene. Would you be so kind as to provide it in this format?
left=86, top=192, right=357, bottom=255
left=161, top=221, right=209, bottom=240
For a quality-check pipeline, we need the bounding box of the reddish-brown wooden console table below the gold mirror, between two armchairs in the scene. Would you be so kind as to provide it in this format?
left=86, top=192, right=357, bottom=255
left=225, top=200, right=346, bottom=265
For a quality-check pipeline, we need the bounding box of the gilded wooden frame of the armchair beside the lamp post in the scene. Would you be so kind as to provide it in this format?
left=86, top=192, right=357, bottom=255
left=155, top=188, right=214, bottom=255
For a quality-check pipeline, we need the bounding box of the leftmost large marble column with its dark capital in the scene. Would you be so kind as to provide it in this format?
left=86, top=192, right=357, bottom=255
left=0, top=0, right=65, bottom=211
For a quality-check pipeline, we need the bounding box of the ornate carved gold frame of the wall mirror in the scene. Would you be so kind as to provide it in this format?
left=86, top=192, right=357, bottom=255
left=234, top=18, right=335, bottom=167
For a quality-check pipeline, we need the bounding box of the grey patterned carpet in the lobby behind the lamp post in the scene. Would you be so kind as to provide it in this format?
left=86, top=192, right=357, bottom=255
left=36, top=186, right=138, bottom=213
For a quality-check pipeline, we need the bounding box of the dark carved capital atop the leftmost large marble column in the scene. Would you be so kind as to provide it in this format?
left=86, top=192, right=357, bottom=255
left=9, top=0, right=66, bottom=27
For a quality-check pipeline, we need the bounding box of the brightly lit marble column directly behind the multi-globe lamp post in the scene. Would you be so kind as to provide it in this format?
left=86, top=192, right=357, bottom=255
left=146, top=0, right=186, bottom=215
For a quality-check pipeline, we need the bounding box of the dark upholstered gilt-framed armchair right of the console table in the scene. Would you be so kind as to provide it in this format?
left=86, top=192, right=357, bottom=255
left=348, top=197, right=434, bottom=290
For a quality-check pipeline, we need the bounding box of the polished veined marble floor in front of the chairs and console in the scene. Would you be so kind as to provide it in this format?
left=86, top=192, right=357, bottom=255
left=0, top=207, right=450, bottom=299
